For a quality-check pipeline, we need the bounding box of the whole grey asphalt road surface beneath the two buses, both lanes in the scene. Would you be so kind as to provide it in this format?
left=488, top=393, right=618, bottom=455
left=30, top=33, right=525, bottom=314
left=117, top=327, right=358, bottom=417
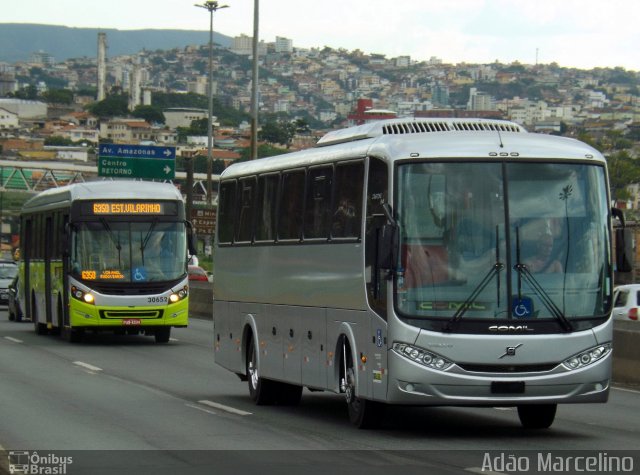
left=0, top=310, right=640, bottom=475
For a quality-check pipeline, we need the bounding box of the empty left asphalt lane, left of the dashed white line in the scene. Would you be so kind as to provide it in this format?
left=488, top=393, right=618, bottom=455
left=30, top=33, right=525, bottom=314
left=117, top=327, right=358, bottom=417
left=0, top=322, right=302, bottom=450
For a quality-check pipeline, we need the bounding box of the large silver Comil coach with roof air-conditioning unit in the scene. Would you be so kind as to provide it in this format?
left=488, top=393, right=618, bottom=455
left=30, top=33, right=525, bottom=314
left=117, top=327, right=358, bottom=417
left=214, top=119, right=618, bottom=428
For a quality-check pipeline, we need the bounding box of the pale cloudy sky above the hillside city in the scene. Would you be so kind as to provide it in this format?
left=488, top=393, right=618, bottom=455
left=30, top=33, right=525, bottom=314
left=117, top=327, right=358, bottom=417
left=5, top=0, right=640, bottom=71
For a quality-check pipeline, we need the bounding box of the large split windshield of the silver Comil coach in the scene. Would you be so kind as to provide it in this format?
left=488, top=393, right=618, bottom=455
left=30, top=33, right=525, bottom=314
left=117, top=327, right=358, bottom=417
left=395, top=162, right=612, bottom=329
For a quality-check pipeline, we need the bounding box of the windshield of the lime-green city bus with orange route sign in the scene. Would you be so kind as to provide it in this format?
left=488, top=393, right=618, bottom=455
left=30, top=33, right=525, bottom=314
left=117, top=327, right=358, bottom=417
left=71, top=219, right=187, bottom=283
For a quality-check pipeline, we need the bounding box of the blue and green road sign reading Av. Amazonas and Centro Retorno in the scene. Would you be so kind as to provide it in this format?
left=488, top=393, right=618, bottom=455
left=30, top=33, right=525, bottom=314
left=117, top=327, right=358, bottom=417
left=98, top=144, right=176, bottom=180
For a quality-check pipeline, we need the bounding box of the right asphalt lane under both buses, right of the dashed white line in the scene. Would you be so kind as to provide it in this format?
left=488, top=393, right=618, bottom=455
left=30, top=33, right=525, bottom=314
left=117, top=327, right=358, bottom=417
left=1, top=314, right=639, bottom=450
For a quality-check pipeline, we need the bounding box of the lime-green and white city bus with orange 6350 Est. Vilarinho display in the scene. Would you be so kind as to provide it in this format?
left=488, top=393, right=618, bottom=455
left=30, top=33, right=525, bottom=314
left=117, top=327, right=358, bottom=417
left=19, top=181, right=191, bottom=343
